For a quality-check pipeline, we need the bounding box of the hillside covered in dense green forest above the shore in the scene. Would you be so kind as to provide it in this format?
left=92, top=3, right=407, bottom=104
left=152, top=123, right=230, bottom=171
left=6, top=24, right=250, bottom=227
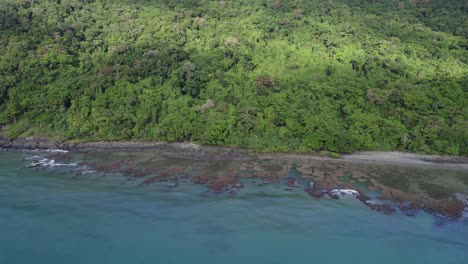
left=0, top=0, right=468, bottom=155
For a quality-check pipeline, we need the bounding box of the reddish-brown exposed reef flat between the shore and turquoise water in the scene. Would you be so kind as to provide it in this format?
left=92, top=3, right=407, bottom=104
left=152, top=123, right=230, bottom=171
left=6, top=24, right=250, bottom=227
left=15, top=143, right=468, bottom=219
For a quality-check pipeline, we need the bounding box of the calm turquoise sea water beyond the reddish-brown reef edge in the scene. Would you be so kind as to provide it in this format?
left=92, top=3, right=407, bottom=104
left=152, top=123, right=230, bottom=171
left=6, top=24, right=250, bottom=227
left=0, top=152, right=468, bottom=264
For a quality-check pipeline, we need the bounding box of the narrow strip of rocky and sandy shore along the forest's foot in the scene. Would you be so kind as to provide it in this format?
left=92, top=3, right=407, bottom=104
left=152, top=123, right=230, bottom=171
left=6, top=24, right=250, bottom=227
left=0, top=137, right=468, bottom=167
